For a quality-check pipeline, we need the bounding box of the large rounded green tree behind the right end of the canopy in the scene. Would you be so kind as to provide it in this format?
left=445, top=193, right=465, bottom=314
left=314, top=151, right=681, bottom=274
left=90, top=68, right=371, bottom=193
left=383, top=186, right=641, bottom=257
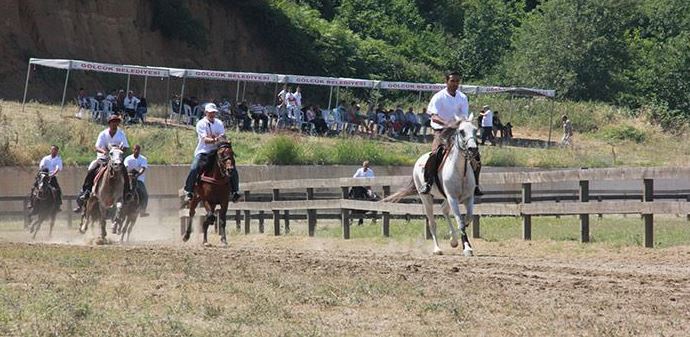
left=503, top=0, right=638, bottom=101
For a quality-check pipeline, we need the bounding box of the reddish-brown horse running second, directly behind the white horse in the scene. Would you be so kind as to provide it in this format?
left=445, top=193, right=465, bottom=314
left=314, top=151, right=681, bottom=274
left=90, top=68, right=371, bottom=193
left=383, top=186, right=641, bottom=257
left=182, top=142, right=235, bottom=246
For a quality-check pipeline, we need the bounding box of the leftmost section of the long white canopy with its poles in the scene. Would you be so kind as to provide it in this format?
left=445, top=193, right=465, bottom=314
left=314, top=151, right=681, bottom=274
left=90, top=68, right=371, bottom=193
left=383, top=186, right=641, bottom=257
left=22, top=58, right=170, bottom=111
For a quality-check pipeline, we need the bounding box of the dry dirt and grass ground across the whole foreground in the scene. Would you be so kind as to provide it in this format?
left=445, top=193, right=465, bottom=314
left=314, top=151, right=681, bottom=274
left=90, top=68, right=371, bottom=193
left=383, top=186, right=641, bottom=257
left=0, top=217, right=690, bottom=336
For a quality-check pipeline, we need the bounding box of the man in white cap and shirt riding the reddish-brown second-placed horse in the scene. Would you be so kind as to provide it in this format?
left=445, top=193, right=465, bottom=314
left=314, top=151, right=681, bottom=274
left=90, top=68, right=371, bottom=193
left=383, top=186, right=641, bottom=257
left=184, top=103, right=240, bottom=202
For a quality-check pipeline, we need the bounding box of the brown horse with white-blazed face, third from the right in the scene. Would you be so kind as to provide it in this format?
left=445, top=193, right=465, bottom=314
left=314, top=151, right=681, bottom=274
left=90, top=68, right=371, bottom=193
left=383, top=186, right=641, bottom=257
left=79, top=146, right=127, bottom=244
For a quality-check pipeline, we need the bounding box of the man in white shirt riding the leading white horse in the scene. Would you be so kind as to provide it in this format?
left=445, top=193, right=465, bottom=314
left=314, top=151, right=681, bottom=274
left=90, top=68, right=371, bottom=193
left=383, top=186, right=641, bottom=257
left=419, top=71, right=482, bottom=195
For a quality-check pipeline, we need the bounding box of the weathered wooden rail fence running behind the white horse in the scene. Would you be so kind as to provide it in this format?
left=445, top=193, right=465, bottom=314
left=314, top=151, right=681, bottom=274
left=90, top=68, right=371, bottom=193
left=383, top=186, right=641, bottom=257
left=179, top=168, right=690, bottom=247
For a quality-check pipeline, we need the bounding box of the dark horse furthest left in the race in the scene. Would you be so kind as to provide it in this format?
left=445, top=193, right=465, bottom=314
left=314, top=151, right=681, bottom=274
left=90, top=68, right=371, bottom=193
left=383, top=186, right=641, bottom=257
left=29, top=171, right=58, bottom=239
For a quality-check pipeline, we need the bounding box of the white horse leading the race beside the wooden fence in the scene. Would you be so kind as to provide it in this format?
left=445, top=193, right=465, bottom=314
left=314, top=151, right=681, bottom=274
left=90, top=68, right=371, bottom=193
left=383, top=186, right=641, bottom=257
left=383, top=115, right=477, bottom=256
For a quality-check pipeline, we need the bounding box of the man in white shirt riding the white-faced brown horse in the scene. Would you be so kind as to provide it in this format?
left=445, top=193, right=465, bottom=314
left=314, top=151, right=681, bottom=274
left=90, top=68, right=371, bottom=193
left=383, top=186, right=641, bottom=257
left=74, top=114, right=130, bottom=213
